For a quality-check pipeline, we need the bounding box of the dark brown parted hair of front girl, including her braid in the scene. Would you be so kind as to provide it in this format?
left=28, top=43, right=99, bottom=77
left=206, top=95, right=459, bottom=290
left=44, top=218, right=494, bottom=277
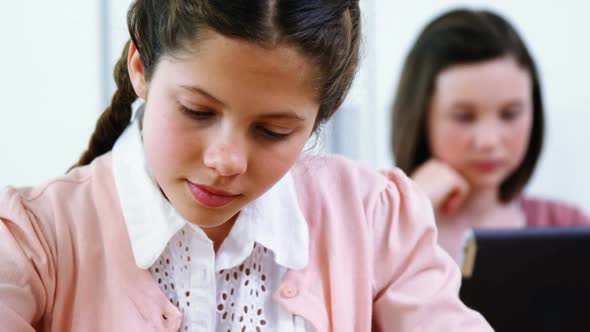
left=74, top=0, right=361, bottom=167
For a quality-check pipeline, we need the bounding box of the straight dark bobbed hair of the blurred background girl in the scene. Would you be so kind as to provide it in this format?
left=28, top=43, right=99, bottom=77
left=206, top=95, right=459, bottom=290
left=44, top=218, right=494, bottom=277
left=392, top=9, right=544, bottom=202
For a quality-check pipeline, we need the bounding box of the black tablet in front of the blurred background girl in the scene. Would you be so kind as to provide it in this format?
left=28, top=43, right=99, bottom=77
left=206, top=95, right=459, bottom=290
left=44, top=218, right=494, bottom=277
left=460, top=227, right=590, bottom=332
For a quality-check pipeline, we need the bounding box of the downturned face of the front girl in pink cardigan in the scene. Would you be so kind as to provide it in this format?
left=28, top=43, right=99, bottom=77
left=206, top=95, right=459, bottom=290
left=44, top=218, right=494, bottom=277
left=130, top=34, right=319, bottom=229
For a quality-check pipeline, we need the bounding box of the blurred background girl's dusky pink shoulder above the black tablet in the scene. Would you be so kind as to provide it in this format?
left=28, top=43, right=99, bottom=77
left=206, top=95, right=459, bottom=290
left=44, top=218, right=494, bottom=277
left=520, top=197, right=590, bottom=227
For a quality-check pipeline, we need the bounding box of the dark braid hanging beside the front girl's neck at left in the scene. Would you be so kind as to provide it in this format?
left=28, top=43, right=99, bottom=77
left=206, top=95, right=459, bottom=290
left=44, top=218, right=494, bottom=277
left=72, top=42, right=137, bottom=168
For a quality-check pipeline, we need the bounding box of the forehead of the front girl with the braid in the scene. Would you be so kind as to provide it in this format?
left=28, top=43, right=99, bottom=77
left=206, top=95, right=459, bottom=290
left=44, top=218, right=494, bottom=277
left=154, top=33, right=319, bottom=113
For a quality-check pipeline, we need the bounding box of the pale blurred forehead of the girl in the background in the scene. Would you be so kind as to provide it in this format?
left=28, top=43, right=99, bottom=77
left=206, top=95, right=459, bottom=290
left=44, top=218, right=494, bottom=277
left=435, top=57, right=532, bottom=102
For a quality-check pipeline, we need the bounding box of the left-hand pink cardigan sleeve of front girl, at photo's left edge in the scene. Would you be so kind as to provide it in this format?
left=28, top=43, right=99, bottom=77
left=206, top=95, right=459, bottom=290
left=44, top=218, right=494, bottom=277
left=0, top=188, right=54, bottom=332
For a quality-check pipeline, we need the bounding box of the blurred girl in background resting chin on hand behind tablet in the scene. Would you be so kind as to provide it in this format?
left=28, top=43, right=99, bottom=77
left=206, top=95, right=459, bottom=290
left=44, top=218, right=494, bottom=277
left=392, top=9, right=590, bottom=260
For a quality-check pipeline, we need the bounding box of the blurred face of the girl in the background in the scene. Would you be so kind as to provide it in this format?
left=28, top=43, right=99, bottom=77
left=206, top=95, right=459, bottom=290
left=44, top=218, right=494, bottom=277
left=428, top=57, right=533, bottom=190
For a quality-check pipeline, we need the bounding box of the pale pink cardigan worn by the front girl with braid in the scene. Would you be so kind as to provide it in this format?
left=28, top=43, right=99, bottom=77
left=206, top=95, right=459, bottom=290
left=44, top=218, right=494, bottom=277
left=0, top=154, right=491, bottom=332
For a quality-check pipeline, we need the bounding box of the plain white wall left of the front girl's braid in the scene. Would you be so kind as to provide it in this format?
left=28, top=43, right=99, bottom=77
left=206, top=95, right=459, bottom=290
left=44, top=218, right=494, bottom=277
left=0, top=0, right=101, bottom=185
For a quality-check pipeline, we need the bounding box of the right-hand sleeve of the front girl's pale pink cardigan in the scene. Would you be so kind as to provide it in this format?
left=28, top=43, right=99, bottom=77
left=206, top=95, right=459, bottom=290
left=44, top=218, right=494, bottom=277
left=367, top=170, right=492, bottom=332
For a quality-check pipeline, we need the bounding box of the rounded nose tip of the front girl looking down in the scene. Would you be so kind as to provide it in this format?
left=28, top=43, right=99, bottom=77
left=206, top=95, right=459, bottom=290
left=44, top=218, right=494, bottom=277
left=203, top=142, right=248, bottom=176
